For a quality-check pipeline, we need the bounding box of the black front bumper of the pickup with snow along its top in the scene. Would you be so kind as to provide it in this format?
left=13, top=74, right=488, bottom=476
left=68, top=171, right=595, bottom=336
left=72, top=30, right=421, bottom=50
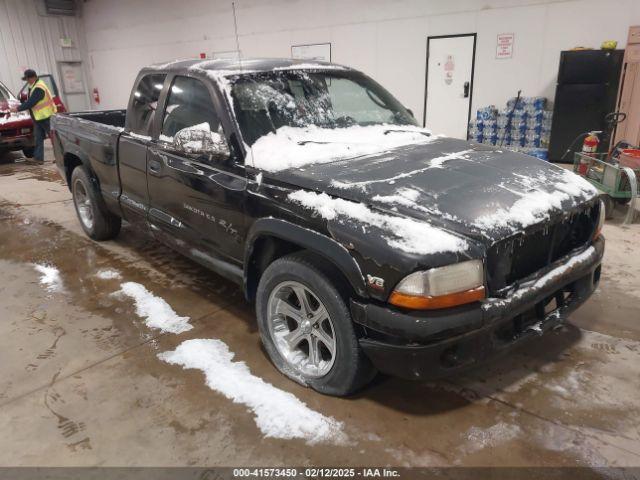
left=351, top=237, right=604, bottom=379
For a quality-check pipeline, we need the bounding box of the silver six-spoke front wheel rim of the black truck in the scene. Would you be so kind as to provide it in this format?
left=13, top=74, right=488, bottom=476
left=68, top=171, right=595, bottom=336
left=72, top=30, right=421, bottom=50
left=267, top=281, right=336, bottom=378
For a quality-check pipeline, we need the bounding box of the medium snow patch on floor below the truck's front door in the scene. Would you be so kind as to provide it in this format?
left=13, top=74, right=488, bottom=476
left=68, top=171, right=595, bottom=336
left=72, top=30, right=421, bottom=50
left=113, top=282, right=193, bottom=333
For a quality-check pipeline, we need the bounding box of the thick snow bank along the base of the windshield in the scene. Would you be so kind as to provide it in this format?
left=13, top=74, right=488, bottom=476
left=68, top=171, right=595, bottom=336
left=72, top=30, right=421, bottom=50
left=246, top=125, right=437, bottom=172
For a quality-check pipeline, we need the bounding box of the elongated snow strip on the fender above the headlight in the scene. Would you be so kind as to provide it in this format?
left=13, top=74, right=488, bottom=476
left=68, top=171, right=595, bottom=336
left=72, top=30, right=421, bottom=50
left=288, top=190, right=469, bottom=255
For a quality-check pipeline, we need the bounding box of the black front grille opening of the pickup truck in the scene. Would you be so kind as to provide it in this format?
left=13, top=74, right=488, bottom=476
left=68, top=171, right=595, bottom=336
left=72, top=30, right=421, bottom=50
left=487, top=202, right=600, bottom=296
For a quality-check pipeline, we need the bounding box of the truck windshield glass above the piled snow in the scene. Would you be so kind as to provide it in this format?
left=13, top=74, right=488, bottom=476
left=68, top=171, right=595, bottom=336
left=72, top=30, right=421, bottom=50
left=229, top=70, right=417, bottom=145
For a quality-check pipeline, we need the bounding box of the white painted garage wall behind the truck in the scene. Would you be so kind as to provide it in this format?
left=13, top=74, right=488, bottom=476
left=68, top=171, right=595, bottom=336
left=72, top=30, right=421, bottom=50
left=84, top=0, right=640, bottom=125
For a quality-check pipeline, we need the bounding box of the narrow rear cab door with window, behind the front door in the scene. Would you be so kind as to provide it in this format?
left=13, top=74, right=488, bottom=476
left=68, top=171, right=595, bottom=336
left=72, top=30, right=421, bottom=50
left=118, top=74, right=166, bottom=229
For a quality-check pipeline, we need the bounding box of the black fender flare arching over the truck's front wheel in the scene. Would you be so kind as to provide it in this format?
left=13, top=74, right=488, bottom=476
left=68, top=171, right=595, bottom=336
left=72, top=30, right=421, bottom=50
left=243, top=218, right=369, bottom=297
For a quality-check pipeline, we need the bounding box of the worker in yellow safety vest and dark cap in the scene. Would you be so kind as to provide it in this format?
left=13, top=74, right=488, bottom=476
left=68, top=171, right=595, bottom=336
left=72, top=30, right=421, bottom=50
left=11, top=69, right=57, bottom=163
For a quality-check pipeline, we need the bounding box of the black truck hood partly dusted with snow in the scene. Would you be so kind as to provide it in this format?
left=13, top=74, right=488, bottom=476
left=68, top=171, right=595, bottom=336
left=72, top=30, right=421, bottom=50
left=268, top=138, right=597, bottom=240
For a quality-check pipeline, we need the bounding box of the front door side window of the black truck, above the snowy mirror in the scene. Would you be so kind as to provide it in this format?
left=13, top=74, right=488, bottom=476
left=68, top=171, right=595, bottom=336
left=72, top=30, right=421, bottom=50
left=162, top=77, right=220, bottom=141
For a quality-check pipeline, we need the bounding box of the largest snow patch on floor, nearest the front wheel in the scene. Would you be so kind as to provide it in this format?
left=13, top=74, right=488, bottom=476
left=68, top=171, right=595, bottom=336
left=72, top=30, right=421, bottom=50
left=158, top=339, right=346, bottom=444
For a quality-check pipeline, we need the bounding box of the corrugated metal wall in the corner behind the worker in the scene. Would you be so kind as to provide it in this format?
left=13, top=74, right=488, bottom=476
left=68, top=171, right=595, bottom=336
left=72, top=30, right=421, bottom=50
left=0, top=0, right=90, bottom=110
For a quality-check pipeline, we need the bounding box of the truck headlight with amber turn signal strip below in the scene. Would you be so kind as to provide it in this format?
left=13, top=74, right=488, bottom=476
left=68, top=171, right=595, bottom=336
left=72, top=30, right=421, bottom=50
left=389, top=260, right=485, bottom=310
